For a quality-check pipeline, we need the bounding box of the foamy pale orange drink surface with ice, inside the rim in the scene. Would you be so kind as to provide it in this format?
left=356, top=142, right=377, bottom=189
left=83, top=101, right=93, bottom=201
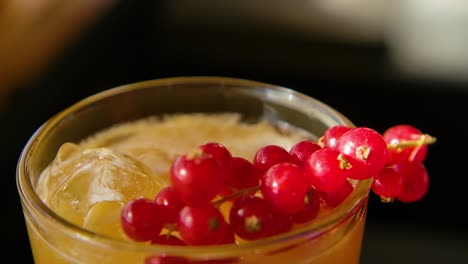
left=37, top=113, right=310, bottom=239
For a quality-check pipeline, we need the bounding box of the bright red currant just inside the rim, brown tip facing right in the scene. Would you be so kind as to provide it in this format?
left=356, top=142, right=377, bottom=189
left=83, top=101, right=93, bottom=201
left=305, top=148, right=351, bottom=191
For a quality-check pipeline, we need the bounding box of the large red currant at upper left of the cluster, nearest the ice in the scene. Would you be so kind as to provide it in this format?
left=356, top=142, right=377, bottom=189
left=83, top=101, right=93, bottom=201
left=170, top=149, right=226, bottom=205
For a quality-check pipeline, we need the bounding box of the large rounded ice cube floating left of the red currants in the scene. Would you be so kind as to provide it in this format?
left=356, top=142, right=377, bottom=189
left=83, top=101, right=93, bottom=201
left=37, top=143, right=167, bottom=226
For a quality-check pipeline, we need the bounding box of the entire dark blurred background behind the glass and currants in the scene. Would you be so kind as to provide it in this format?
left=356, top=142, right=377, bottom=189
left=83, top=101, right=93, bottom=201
left=0, top=0, right=468, bottom=264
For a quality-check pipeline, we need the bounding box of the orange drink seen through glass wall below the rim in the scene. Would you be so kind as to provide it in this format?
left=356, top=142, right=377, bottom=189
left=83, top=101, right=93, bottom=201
left=27, top=205, right=365, bottom=264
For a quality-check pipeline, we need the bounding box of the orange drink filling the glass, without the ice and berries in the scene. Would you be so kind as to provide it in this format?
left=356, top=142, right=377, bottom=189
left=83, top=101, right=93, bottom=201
left=25, top=113, right=367, bottom=264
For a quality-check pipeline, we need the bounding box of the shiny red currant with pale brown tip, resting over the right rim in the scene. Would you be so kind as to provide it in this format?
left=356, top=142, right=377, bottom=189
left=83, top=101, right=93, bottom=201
left=336, top=127, right=388, bottom=180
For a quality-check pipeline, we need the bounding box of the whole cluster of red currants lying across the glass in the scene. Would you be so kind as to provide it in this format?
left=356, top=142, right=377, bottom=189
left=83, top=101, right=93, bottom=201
left=121, top=125, right=435, bottom=255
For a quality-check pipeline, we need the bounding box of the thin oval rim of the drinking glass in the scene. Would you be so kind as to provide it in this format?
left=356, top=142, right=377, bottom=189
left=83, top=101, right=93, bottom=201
left=16, top=76, right=371, bottom=256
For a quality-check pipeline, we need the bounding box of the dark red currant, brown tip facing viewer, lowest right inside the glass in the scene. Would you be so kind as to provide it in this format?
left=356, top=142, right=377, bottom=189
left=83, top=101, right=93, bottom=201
left=229, top=195, right=273, bottom=240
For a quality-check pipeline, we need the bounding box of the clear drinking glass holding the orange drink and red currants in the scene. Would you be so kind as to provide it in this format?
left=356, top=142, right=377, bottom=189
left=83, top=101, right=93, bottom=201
left=17, top=76, right=371, bottom=264
